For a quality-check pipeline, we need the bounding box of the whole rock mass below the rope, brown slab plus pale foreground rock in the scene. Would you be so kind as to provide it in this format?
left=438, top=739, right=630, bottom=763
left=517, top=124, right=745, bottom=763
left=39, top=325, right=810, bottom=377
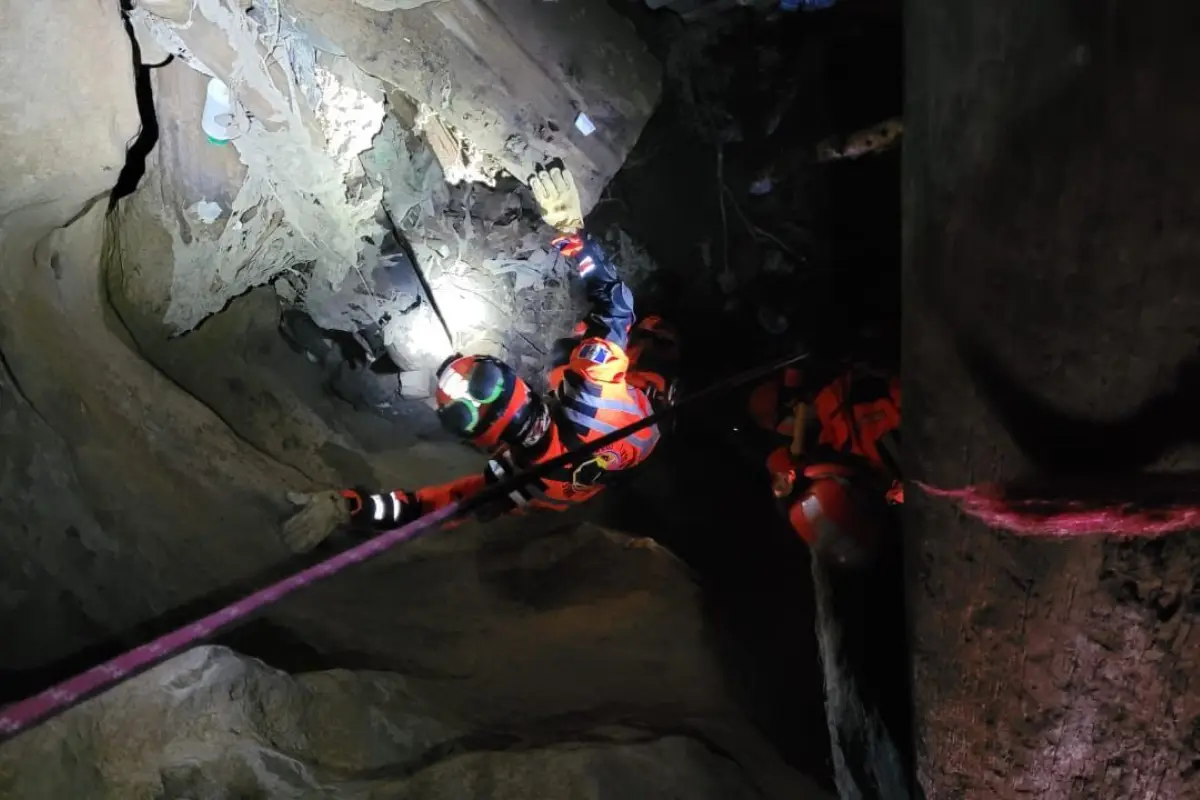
left=0, top=527, right=826, bottom=800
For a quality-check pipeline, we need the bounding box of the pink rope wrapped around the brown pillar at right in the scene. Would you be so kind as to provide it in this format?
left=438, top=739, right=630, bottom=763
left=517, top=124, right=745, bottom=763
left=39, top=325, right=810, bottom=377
left=917, top=473, right=1200, bottom=539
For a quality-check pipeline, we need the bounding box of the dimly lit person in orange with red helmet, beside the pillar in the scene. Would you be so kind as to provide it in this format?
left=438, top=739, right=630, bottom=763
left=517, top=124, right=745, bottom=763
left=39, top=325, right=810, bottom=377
left=749, top=368, right=904, bottom=566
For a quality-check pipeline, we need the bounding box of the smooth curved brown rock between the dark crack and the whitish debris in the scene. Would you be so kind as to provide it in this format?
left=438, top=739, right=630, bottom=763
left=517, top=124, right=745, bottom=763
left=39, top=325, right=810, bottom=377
left=110, top=53, right=478, bottom=488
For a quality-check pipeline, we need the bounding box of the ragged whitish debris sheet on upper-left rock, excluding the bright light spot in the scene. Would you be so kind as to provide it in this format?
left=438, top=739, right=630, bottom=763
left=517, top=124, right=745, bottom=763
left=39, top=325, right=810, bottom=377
left=136, top=0, right=384, bottom=333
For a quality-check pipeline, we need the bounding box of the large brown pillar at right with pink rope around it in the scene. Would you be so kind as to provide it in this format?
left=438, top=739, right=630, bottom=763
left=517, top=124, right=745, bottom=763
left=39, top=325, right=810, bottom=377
left=902, top=0, right=1200, bottom=800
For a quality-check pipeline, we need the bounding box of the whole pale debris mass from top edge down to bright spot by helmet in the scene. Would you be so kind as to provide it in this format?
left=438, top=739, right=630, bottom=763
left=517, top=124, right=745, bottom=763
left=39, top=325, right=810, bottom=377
left=133, top=0, right=653, bottom=388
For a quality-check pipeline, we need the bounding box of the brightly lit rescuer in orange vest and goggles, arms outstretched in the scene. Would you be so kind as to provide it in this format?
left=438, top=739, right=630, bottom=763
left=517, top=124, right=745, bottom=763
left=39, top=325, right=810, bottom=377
left=284, top=163, right=678, bottom=551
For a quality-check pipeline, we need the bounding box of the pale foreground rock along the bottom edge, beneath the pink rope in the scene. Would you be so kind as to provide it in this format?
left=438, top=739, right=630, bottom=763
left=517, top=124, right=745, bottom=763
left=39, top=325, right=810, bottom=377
left=0, top=646, right=762, bottom=800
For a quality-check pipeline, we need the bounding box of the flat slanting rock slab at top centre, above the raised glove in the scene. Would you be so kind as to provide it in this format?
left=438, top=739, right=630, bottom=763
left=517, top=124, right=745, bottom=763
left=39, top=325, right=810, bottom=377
left=294, top=0, right=660, bottom=210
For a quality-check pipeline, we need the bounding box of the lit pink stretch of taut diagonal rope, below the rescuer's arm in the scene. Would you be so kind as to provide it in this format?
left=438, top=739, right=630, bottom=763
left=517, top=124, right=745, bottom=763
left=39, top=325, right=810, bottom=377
left=0, top=503, right=460, bottom=742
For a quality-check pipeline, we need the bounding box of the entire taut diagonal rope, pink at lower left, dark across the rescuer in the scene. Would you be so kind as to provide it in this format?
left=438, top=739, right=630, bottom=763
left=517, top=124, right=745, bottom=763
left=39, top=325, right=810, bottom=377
left=0, top=353, right=808, bottom=744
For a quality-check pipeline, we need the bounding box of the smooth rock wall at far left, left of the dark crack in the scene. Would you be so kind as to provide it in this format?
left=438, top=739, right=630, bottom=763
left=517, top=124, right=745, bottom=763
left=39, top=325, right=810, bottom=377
left=0, top=1, right=314, bottom=669
